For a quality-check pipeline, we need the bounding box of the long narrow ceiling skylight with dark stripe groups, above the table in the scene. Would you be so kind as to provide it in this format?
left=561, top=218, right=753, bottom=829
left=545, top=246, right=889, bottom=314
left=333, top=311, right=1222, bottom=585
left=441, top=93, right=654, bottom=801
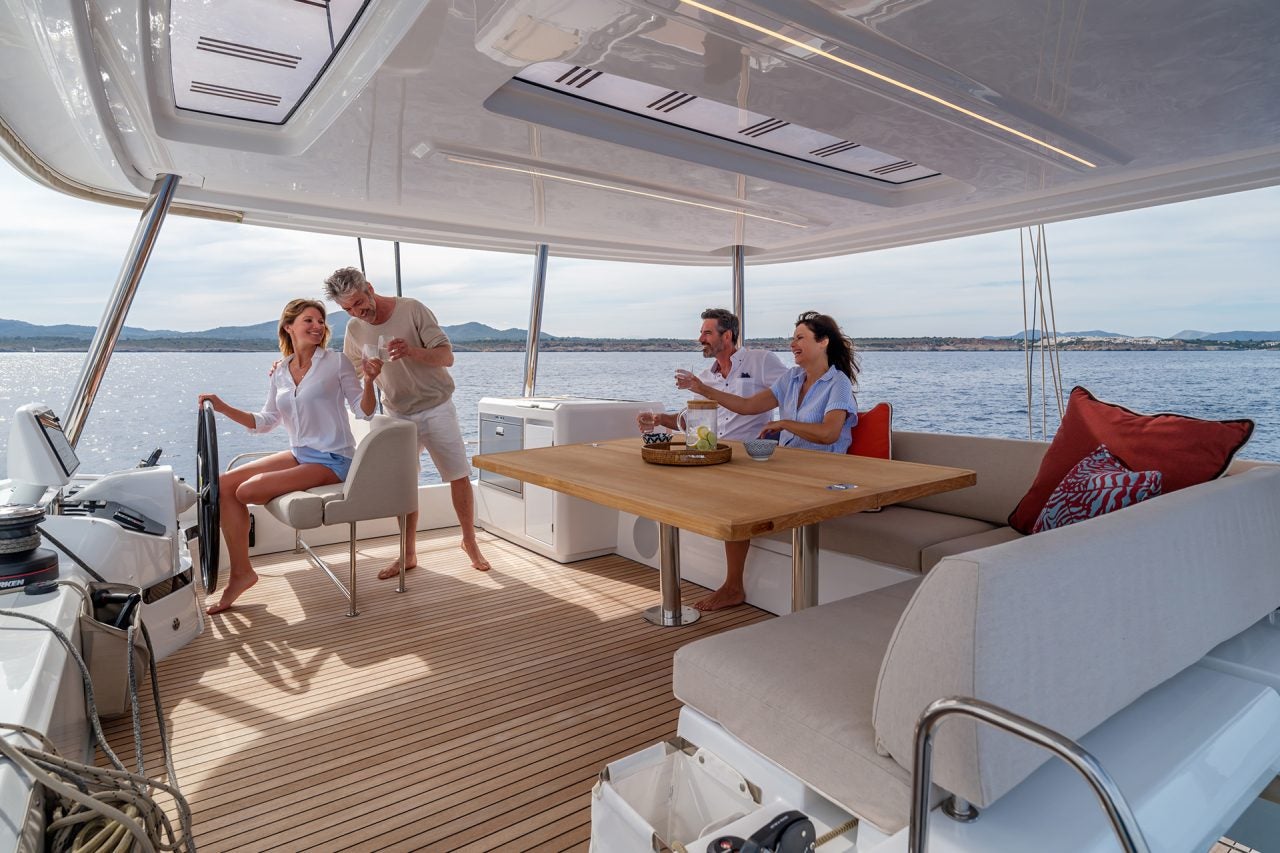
left=516, top=61, right=940, bottom=186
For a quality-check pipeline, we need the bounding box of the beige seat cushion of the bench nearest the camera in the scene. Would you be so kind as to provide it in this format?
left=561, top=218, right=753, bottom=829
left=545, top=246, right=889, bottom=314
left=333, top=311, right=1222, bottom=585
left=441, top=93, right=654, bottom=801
left=673, top=580, right=919, bottom=833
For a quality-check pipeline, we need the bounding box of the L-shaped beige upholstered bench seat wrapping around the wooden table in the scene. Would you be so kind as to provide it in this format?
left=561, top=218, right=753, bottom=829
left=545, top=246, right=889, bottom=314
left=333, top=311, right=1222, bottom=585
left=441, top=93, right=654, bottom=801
left=675, top=433, right=1280, bottom=833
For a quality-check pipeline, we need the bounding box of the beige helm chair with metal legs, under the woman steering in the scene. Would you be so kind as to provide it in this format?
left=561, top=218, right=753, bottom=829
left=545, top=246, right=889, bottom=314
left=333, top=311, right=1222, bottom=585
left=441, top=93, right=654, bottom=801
left=266, top=415, right=417, bottom=616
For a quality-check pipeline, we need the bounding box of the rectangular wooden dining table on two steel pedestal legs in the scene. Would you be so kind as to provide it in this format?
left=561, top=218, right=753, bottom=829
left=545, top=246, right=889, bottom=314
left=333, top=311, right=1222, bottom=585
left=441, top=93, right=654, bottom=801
left=471, top=437, right=977, bottom=626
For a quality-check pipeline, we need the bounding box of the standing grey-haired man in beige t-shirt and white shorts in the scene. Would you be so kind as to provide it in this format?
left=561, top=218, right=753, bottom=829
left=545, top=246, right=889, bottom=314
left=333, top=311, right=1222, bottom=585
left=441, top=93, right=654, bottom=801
left=324, top=266, right=489, bottom=579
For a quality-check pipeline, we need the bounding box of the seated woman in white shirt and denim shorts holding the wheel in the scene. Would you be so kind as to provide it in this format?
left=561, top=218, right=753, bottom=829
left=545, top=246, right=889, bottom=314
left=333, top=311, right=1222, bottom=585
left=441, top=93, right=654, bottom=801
left=200, top=300, right=383, bottom=613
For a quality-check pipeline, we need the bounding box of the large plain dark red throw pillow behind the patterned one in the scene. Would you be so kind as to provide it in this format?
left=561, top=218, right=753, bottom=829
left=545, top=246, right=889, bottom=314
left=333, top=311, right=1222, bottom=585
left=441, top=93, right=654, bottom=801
left=1009, top=387, right=1253, bottom=533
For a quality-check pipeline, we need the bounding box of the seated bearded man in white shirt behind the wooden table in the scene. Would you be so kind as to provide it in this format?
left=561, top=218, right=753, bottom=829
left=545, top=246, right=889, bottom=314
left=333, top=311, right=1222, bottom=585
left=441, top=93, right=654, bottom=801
left=641, top=309, right=787, bottom=611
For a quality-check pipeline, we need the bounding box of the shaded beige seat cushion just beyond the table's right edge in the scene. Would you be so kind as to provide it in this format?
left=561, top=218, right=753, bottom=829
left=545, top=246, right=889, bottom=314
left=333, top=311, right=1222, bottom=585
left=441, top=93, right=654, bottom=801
left=772, top=506, right=995, bottom=571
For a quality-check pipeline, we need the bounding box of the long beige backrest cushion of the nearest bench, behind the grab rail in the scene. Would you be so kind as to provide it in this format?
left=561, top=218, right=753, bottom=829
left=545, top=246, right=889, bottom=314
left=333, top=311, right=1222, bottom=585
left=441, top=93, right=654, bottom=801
left=875, top=467, right=1280, bottom=807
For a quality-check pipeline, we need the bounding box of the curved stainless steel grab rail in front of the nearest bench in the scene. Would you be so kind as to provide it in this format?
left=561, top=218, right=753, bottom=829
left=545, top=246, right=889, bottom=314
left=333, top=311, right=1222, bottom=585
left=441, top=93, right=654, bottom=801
left=908, top=697, right=1151, bottom=853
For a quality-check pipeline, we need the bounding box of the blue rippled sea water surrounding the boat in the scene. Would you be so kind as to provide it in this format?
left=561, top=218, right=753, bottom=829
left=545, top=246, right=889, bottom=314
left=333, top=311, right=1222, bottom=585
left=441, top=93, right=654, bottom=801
left=0, top=351, right=1280, bottom=483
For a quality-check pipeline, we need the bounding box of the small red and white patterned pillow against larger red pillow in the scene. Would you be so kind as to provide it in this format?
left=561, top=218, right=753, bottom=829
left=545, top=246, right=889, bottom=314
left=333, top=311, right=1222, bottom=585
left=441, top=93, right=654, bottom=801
left=1032, top=444, right=1164, bottom=533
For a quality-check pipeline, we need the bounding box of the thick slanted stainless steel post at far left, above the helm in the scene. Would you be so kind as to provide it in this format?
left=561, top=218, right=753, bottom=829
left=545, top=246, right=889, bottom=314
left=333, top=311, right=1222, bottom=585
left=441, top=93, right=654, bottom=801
left=63, top=174, right=179, bottom=447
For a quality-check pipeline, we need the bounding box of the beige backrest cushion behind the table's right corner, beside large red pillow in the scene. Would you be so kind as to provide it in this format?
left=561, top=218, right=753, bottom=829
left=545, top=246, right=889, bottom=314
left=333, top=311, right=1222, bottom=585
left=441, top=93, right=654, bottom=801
left=893, top=430, right=1048, bottom=525
